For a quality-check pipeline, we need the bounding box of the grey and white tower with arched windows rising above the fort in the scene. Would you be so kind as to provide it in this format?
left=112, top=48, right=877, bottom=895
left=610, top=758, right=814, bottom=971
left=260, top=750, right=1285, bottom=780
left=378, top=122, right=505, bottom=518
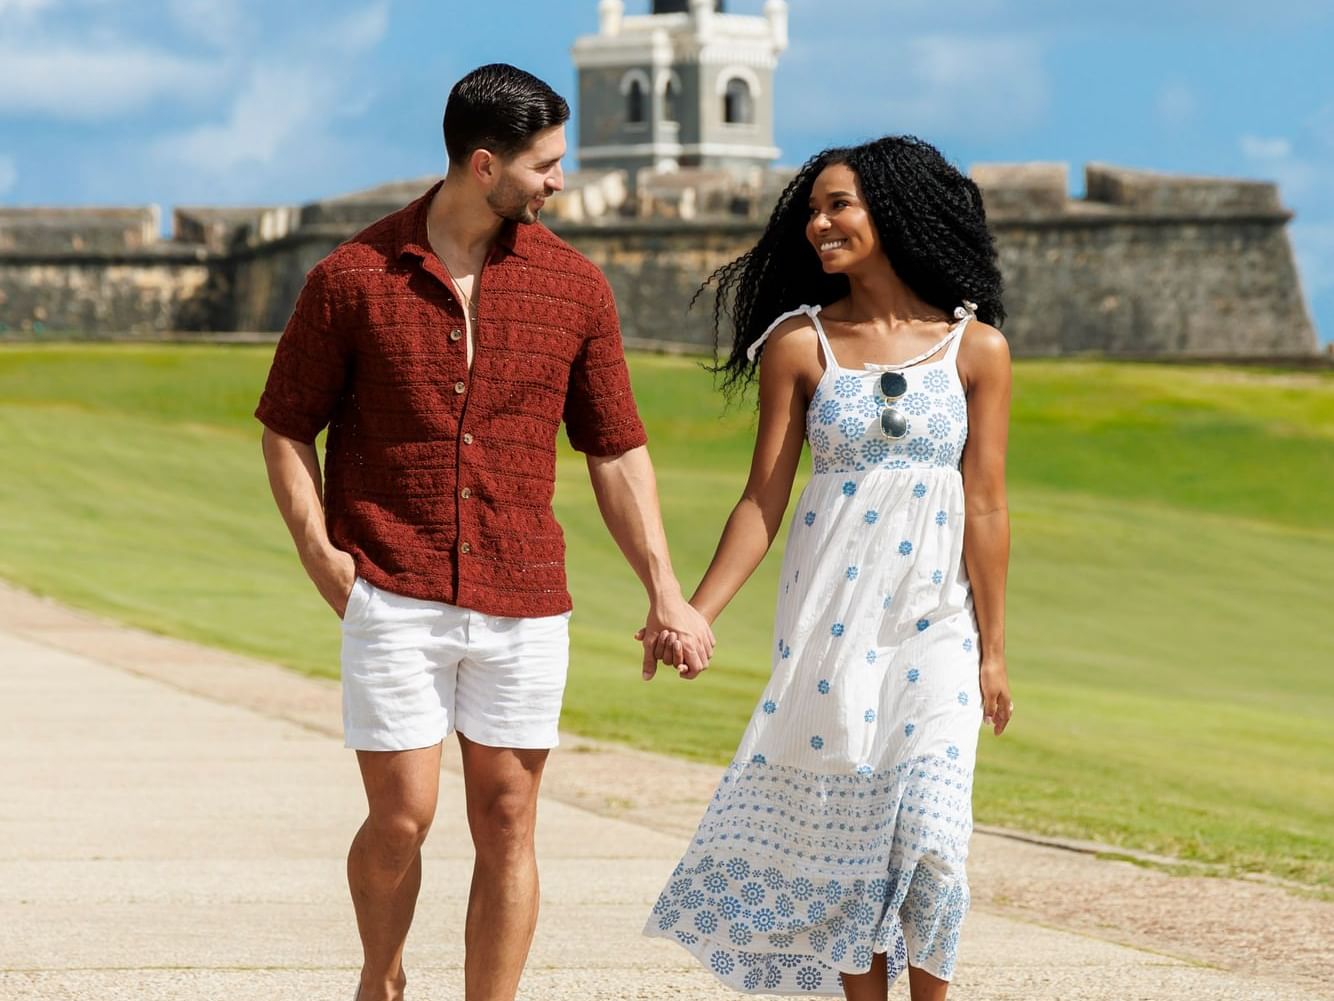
left=574, top=0, right=787, bottom=184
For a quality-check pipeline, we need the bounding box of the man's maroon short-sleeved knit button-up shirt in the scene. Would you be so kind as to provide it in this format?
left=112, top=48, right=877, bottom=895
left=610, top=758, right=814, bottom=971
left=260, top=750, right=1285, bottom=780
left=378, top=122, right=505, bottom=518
left=255, top=184, right=647, bottom=617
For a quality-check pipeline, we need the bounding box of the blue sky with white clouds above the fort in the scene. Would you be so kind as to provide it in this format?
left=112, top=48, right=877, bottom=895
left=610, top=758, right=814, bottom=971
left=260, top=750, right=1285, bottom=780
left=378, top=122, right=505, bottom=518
left=0, top=0, right=1334, bottom=342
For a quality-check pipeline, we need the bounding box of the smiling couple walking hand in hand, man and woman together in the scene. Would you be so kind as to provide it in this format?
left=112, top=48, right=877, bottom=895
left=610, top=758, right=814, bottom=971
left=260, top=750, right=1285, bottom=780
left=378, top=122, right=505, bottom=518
left=256, top=64, right=1013, bottom=1001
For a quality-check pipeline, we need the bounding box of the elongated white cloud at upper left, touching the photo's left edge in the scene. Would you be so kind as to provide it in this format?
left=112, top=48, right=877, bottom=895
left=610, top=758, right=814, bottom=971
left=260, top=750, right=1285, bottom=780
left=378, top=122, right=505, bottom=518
left=0, top=44, right=220, bottom=121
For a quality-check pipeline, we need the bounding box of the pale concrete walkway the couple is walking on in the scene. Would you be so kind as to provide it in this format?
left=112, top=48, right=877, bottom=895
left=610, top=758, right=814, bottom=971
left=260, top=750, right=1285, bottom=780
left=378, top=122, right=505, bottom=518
left=0, top=589, right=1329, bottom=1001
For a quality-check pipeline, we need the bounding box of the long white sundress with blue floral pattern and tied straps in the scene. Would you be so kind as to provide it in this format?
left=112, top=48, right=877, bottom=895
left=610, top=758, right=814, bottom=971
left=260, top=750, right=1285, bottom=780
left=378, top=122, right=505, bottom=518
left=644, top=307, right=982, bottom=996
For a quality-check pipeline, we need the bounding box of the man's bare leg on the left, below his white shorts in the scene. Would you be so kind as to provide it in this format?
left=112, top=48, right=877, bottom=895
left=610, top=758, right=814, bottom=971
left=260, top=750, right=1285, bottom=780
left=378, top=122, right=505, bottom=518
left=347, top=743, right=440, bottom=1001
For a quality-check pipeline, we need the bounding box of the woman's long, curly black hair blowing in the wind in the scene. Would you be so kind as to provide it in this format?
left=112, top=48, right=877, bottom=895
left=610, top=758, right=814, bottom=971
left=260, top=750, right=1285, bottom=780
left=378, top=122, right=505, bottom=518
left=695, top=136, right=1005, bottom=395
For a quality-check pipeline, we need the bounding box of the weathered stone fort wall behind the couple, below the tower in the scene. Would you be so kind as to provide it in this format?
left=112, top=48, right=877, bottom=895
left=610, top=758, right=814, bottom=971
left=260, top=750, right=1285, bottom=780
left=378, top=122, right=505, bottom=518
left=0, top=164, right=1317, bottom=358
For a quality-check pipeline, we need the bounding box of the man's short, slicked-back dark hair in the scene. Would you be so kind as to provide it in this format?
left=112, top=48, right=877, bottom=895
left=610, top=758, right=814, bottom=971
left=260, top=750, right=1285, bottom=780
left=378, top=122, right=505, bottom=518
left=444, top=63, right=570, bottom=164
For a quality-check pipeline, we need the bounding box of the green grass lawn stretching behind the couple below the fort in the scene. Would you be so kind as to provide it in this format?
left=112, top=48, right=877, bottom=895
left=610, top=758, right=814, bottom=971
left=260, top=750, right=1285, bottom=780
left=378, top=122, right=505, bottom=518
left=0, top=346, right=1334, bottom=892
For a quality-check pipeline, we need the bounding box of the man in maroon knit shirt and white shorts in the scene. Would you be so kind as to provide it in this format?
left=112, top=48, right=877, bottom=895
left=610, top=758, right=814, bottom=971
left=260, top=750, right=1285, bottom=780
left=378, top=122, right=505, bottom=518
left=256, top=65, right=714, bottom=1001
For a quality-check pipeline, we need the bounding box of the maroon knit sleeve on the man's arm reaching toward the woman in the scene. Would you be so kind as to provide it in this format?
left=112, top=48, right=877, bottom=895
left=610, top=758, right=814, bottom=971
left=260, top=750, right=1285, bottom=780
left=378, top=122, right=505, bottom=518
left=564, top=279, right=648, bottom=455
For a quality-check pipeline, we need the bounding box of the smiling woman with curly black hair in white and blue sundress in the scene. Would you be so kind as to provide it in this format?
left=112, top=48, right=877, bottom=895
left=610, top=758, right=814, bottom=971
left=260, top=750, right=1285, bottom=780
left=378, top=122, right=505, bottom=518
left=644, top=137, right=1013, bottom=1001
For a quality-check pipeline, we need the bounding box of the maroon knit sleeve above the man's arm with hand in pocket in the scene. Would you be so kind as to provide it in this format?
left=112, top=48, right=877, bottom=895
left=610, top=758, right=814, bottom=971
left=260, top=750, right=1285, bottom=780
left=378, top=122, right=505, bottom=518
left=255, top=266, right=350, bottom=442
